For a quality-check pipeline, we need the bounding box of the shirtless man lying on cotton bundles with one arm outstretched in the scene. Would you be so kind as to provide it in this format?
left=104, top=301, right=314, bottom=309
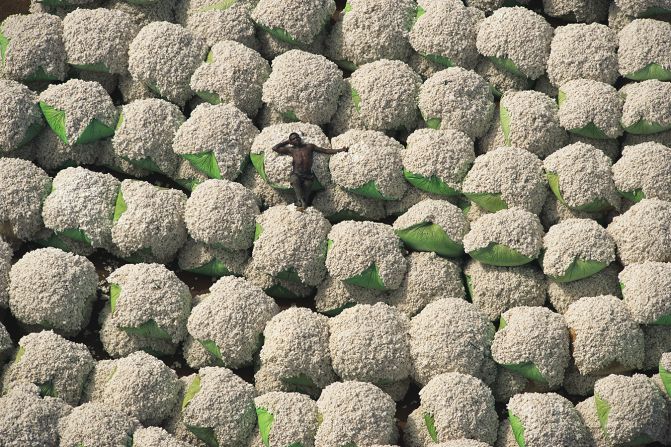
left=273, top=132, right=349, bottom=209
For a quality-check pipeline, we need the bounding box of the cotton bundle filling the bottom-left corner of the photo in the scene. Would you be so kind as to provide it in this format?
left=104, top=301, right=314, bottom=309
left=0, top=383, right=72, bottom=447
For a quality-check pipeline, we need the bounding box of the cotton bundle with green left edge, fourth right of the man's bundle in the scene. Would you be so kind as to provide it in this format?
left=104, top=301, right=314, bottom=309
left=544, top=143, right=620, bottom=213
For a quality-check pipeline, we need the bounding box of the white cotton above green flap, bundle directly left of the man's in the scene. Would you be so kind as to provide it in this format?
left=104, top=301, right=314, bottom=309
left=173, top=104, right=259, bottom=180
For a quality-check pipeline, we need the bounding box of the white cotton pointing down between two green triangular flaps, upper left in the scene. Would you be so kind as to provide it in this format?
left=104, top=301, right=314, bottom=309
left=40, top=79, right=119, bottom=146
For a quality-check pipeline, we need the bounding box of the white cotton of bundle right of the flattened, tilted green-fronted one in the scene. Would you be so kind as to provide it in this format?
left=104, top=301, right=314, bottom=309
left=464, top=208, right=544, bottom=259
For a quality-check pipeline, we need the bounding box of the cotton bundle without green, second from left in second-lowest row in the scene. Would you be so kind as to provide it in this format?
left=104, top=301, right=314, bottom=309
left=87, top=351, right=181, bottom=425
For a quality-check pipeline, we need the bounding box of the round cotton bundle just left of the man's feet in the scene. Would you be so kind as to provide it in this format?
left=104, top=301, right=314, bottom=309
left=184, top=180, right=260, bottom=250
